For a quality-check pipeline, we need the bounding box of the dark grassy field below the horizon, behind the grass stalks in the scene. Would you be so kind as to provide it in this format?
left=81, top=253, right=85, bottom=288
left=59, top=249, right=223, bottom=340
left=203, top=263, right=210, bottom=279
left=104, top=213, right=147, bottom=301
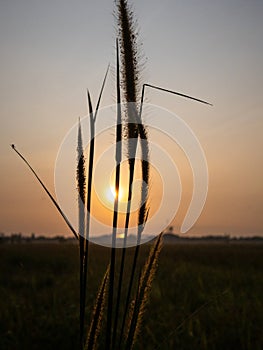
left=0, top=243, right=263, bottom=350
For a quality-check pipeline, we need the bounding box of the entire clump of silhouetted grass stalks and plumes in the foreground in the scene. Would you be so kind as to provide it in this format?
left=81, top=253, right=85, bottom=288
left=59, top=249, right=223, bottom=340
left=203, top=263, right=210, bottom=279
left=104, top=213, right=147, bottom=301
left=12, top=0, right=210, bottom=350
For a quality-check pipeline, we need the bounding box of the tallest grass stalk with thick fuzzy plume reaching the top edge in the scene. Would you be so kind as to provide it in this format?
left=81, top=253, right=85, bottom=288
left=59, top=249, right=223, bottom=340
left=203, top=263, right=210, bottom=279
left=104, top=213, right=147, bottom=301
left=113, top=0, right=149, bottom=346
